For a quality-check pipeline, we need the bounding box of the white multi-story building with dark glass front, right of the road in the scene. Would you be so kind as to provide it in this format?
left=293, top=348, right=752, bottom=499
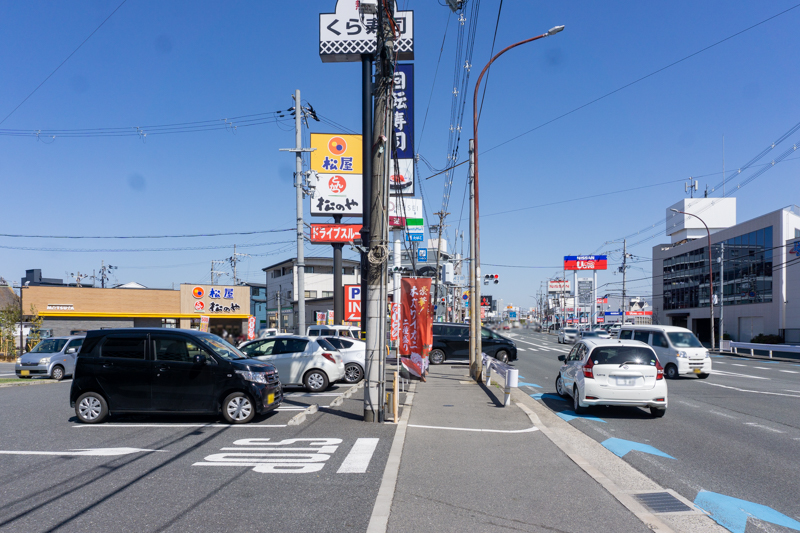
left=653, top=198, right=800, bottom=342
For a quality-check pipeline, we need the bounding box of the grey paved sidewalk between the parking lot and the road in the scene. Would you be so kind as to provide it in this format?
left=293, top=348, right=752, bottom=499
left=387, top=364, right=651, bottom=533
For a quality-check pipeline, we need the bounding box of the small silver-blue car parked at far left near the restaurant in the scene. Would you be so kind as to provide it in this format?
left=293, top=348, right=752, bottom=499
left=14, top=335, right=84, bottom=381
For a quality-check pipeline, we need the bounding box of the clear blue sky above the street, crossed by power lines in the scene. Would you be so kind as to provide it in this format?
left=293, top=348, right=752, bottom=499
left=0, top=0, right=800, bottom=305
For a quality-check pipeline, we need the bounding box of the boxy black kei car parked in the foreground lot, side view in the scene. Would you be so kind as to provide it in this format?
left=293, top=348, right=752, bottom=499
left=69, top=328, right=283, bottom=424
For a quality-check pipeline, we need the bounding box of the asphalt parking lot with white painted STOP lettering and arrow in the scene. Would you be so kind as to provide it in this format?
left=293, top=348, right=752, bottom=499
left=0, top=381, right=395, bottom=532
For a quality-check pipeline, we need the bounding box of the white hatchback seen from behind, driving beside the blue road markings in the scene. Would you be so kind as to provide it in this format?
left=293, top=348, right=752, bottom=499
left=556, top=339, right=667, bottom=417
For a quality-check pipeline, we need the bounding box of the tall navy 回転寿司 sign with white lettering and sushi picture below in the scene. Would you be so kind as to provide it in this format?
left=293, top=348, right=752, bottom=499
left=390, top=63, right=414, bottom=196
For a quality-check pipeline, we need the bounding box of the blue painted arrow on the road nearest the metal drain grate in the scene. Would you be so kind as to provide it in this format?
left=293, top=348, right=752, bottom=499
left=694, top=490, right=800, bottom=533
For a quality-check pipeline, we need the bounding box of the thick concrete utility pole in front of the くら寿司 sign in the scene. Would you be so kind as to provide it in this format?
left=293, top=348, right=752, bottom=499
left=362, top=0, right=394, bottom=422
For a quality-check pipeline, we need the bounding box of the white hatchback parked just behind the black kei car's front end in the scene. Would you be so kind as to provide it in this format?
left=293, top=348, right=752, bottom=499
left=241, top=335, right=344, bottom=392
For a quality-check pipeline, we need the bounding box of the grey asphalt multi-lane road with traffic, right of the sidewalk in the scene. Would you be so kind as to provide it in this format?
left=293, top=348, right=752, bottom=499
left=506, top=329, right=800, bottom=532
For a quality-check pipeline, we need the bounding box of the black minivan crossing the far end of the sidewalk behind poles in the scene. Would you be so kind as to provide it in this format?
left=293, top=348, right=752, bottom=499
left=428, top=322, right=517, bottom=365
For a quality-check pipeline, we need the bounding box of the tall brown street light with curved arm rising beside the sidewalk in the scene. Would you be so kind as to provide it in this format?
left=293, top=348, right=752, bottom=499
left=470, top=26, right=564, bottom=380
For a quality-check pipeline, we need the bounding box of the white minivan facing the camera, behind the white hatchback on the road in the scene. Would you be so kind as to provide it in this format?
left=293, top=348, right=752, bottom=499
left=619, top=324, right=711, bottom=379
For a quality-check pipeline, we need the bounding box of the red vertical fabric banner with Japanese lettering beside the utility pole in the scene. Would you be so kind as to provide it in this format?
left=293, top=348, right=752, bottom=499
left=400, top=278, right=433, bottom=357
